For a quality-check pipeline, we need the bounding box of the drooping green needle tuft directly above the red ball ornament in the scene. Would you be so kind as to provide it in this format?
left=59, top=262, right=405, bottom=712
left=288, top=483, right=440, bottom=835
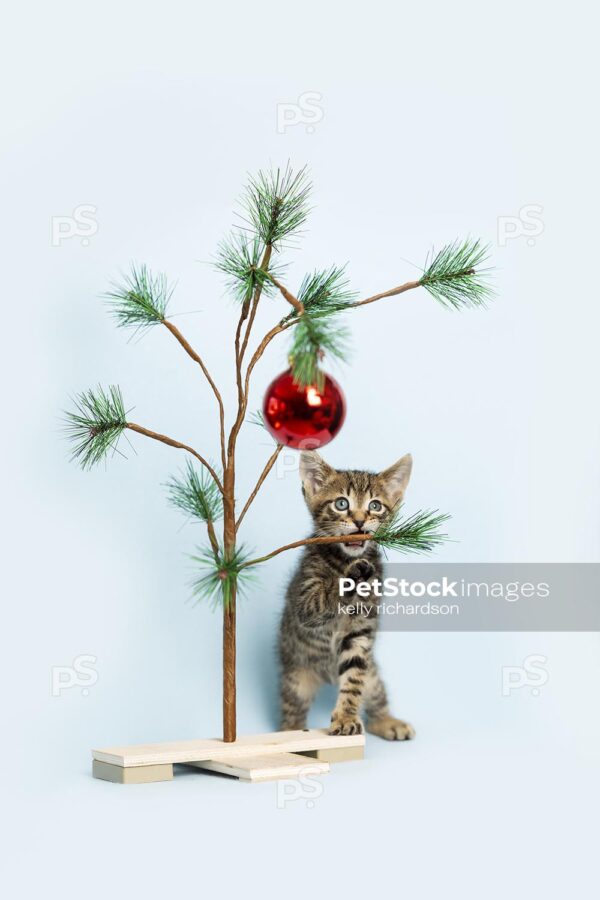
left=290, top=310, right=349, bottom=391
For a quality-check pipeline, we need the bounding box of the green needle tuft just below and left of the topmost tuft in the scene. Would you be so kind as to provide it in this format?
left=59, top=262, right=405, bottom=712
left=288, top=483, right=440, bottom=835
left=215, top=232, right=284, bottom=303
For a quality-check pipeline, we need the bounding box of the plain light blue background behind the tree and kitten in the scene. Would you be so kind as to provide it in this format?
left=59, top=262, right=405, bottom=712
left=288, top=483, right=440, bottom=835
left=0, top=0, right=600, bottom=898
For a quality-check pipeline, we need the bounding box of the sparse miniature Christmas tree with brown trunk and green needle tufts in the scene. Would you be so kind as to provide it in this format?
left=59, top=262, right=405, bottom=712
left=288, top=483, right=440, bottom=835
left=67, top=167, right=491, bottom=742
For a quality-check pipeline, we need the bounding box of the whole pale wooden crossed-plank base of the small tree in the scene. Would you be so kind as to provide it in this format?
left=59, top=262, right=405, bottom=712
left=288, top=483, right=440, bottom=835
left=92, top=729, right=365, bottom=784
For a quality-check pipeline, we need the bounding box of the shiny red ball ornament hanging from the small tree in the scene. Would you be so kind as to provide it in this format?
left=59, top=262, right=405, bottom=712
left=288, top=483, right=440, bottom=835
left=263, top=369, right=346, bottom=450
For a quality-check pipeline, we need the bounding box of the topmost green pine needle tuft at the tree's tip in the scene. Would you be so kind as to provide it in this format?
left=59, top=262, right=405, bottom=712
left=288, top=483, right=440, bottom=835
left=242, top=165, right=311, bottom=247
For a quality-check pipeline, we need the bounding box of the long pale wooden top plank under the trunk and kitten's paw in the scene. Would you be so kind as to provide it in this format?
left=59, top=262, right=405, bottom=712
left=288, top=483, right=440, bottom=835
left=92, top=729, right=365, bottom=768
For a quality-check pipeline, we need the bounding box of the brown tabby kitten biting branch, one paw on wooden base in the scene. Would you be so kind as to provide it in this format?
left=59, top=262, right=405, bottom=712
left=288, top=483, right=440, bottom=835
left=279, top=451, right=415, bottom=741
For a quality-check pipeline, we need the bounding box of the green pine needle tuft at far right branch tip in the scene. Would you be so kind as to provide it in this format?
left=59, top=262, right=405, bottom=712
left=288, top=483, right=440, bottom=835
left=419, top=238, right=494, bottom=309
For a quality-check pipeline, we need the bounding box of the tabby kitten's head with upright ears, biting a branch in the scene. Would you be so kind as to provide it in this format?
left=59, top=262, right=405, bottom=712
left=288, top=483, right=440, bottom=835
left=300, top=450, right=412, bottom=556
